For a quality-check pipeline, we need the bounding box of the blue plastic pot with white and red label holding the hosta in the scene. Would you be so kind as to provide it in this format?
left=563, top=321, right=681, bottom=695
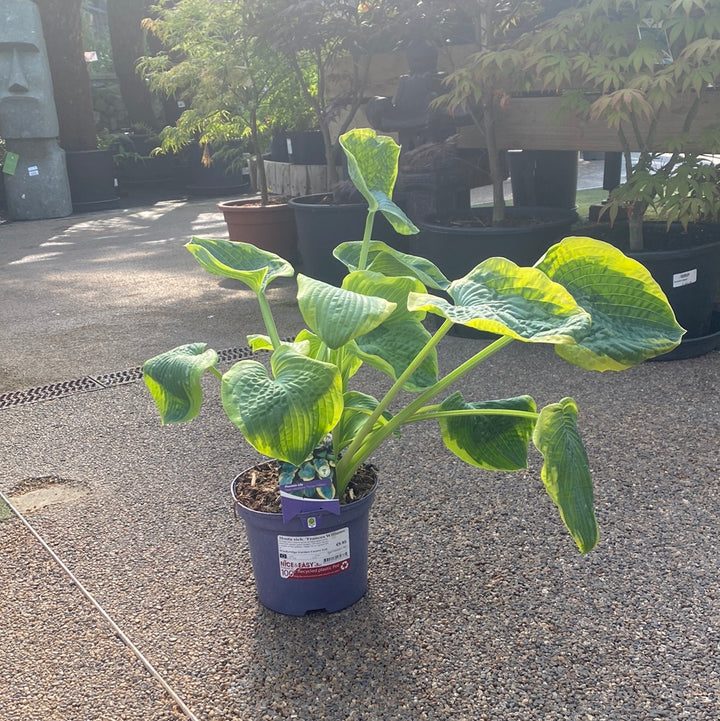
left=231, top=474, right=377, bottom=616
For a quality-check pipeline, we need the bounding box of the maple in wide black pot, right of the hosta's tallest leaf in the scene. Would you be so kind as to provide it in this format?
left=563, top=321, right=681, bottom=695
left=396, top=0, right=576, bottom=274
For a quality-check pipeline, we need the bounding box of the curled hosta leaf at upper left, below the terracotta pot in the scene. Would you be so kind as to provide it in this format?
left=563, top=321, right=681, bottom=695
left=185, top=238, right=295, bottom=294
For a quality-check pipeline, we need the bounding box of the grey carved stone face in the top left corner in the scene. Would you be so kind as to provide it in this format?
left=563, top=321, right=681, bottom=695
left=0, top=0, right=59, bottom=138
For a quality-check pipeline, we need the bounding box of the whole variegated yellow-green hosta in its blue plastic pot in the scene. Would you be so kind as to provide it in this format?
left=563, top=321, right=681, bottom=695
left=143, top=129, right=683, bottom=615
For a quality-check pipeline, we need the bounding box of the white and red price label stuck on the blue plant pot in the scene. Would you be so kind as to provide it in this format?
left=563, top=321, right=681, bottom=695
left=277, top=527, right=350, bottom=579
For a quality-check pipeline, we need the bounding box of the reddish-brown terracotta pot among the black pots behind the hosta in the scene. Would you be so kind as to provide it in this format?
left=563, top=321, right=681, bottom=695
left=218, top=199, right=297, bottom=261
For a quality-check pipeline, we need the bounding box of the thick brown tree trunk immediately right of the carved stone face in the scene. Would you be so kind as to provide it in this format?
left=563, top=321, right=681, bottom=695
left=35, top=0, right=97, bottom=150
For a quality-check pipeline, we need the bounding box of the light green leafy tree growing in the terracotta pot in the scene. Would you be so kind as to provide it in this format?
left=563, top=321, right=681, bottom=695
left=139, top=0, right=306, bottom=258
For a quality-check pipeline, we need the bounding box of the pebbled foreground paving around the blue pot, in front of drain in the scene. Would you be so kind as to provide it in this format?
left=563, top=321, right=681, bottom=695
left=0, top=339, right=720, bottom=721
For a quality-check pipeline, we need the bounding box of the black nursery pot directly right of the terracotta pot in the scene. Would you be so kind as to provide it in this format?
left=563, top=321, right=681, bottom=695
left=290, top=193, right=408, bottom=286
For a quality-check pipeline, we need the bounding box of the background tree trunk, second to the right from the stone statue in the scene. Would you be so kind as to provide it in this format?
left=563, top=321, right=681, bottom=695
left=107, top=0, right=162, bottom=130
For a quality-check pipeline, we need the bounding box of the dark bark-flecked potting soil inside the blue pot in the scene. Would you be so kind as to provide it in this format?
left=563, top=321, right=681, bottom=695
left=234, top=461, right=377, bottom=513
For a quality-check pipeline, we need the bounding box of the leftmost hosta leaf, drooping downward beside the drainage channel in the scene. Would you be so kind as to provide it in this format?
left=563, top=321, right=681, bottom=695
left=143, top=343, right=218, bottom=424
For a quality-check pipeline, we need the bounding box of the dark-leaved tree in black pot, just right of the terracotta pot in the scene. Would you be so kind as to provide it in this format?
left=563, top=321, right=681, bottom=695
left=266, top=0, right=408, bottom=283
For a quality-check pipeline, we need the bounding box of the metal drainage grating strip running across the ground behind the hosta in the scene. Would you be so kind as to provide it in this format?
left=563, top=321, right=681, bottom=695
left=0, top=346, right=254, bottom=410
